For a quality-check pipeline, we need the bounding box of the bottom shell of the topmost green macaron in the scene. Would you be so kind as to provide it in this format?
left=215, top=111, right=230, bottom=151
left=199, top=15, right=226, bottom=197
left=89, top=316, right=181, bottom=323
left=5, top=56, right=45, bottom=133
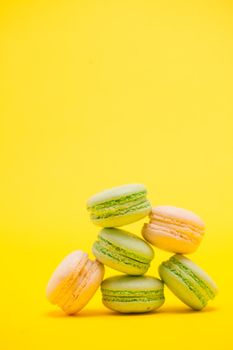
left=91, top=207, right=151, bottom=227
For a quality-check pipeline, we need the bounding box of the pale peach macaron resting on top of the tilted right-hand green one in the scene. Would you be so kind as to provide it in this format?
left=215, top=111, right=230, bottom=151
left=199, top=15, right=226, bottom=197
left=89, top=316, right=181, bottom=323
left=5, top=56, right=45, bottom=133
left=142, top=206, right=205, bottom=254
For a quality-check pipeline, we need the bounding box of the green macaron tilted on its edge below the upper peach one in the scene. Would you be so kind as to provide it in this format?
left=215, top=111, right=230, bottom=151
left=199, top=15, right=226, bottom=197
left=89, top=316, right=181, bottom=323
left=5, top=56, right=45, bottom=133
left=159, top=255, right=217, bottom=310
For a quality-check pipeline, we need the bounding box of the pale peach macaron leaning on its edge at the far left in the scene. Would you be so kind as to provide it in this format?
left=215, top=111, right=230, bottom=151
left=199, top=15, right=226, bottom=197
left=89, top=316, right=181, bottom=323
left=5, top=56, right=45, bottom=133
left=46, top=250, right=104, bottom=314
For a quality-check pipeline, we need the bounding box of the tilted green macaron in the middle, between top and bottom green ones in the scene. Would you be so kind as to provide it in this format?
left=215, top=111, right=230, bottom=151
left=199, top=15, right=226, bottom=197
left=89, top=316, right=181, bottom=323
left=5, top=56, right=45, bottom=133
left=92, top=228, right=154, bottom=275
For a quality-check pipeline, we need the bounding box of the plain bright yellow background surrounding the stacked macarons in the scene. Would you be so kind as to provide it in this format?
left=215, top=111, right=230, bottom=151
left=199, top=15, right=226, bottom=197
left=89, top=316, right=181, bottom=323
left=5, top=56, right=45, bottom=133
left=0, top=0, right=233, bottom=350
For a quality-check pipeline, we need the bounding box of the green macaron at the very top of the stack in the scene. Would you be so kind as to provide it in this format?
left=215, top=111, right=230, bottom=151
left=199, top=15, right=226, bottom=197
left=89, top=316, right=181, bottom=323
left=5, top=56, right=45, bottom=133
left=87, top=184, right=151, bottom=227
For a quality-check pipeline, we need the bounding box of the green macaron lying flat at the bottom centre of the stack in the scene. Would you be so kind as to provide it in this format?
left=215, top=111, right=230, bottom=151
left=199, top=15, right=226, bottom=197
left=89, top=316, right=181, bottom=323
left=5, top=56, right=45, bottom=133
left=101, top=275, right=164, bottom=313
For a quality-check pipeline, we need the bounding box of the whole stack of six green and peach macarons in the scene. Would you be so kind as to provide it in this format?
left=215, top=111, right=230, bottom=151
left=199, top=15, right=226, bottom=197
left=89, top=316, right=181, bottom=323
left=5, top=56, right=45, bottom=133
left=46, top=184, right=217, bottom=314
